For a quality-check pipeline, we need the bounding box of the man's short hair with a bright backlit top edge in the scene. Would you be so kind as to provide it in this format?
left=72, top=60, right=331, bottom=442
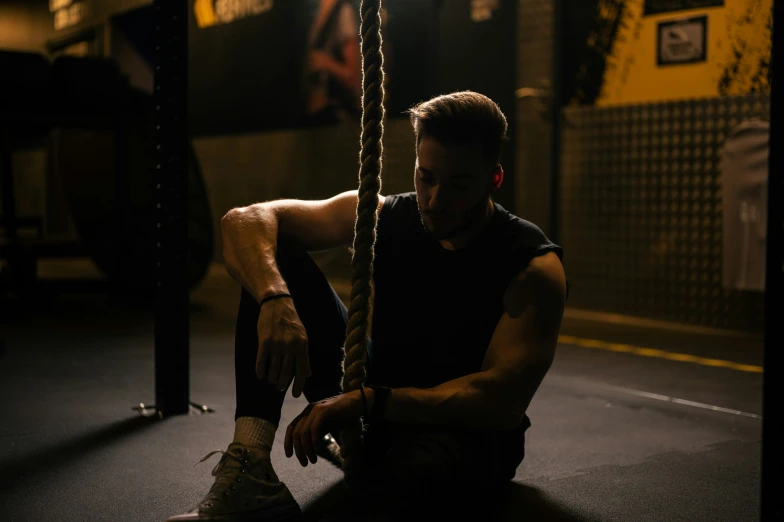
left=406, top=91, right=509, bottom=163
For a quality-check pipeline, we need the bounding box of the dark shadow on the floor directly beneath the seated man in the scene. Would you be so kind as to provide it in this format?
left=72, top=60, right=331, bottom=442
left=303, top=481, right=596, bottom=522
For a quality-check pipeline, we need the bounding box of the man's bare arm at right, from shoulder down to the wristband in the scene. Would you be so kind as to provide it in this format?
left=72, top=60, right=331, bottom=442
left=368, top=253, right=566, bottom=430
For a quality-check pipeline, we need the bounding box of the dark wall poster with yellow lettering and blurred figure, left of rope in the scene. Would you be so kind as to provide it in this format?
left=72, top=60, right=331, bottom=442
left=189, top=0, right=362, bottom=134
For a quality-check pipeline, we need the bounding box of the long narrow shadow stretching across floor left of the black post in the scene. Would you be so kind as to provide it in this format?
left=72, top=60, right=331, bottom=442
left=0, top=415, right=160, bottom=492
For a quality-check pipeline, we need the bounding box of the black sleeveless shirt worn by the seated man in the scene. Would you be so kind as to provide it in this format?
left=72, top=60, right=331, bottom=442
left=366, top=192, right=563, bottom=470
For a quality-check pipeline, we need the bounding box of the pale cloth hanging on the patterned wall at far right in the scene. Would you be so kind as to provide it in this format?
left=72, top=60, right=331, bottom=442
left=721, top=120, right=770, bottom=292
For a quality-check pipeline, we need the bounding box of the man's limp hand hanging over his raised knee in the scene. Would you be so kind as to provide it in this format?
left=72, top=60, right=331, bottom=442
left=256, top=297, right=311, bottom=397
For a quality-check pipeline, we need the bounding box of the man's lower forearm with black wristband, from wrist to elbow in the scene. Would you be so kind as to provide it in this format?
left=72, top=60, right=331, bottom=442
left=370, top=372, right=522, bottom=430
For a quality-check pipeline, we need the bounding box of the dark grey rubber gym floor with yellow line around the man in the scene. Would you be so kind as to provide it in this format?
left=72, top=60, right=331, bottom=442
left=0, top=265, right=762, bottom=522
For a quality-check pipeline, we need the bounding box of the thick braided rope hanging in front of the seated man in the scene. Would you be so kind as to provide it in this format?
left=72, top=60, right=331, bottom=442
left=340, top=0, right=384, bottom=487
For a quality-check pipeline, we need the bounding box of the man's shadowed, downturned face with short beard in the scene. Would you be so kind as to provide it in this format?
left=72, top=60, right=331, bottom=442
left=414, top=136, right=500, bottom=240
